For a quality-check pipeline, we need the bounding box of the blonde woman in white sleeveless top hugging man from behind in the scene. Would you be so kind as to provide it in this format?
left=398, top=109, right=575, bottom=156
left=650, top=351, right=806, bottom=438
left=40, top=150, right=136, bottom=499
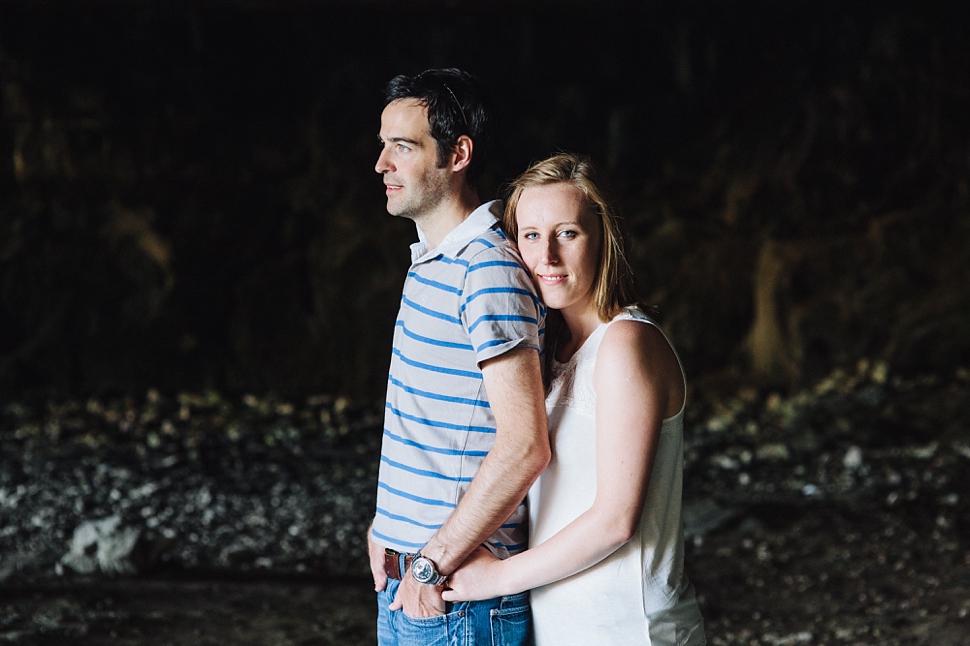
left=442, top=154, right=706, bottom=646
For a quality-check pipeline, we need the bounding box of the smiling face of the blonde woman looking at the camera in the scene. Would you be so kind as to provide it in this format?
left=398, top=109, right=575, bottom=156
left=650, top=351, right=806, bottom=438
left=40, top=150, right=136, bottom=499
left=515, top=182, right=603, bottom=315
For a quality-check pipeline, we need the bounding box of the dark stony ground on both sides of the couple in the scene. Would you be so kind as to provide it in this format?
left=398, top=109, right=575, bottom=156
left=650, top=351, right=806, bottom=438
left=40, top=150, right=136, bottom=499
left=0, top=362, right=970, bottom=646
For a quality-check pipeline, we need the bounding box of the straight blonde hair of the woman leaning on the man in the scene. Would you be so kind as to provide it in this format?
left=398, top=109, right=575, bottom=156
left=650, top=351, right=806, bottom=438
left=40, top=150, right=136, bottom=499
left=502, top=153, right=639, bottom=321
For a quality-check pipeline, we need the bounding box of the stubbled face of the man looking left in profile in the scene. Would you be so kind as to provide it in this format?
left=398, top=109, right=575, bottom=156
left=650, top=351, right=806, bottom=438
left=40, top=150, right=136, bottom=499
left=374, top=99, right=451, bottom=220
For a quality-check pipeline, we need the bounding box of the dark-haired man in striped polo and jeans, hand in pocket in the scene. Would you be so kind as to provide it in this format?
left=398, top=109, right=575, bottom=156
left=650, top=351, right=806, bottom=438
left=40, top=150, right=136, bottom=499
left=368, top=69, right=550, bottom=646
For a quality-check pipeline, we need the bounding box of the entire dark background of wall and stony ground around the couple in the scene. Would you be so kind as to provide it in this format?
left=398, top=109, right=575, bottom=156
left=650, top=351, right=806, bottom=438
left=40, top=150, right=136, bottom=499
left=0, top=0, right=970, bottom=646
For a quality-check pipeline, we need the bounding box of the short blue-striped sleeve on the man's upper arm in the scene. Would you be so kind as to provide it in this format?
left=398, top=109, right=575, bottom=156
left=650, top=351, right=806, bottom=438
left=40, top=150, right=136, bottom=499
left=461, top=246, right=545, bottom=365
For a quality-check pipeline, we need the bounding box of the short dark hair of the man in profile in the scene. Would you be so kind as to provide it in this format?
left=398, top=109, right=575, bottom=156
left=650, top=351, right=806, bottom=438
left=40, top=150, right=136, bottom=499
left=384, top=68, right=490, bottom=184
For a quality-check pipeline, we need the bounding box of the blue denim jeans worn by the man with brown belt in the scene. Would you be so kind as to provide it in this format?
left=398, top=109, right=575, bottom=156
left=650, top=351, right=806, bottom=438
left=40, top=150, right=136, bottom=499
left=377, top=557, right=533, bottom=646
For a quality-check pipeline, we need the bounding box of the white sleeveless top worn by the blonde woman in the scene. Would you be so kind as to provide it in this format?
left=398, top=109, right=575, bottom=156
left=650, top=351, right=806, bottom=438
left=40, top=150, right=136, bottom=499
left=529, top=308, right=706, bottom=646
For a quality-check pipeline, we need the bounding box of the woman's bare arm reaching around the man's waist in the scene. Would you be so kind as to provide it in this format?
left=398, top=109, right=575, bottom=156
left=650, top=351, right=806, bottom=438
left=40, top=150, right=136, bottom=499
left=442, top=321, right=684, bottom=601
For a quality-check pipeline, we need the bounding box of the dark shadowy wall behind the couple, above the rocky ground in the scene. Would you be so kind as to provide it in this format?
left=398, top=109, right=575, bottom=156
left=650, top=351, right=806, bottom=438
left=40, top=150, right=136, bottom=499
left=0, top=2, right=970, bottom=396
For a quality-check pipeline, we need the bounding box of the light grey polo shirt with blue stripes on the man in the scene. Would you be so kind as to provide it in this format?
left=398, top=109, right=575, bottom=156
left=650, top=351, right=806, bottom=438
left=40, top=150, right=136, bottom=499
left=373, top=201, right=545, bottom=557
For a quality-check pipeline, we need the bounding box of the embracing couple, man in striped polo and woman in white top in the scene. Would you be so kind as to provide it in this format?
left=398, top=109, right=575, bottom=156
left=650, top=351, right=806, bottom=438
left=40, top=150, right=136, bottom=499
left=368, top=69, right=705, bottom=646
